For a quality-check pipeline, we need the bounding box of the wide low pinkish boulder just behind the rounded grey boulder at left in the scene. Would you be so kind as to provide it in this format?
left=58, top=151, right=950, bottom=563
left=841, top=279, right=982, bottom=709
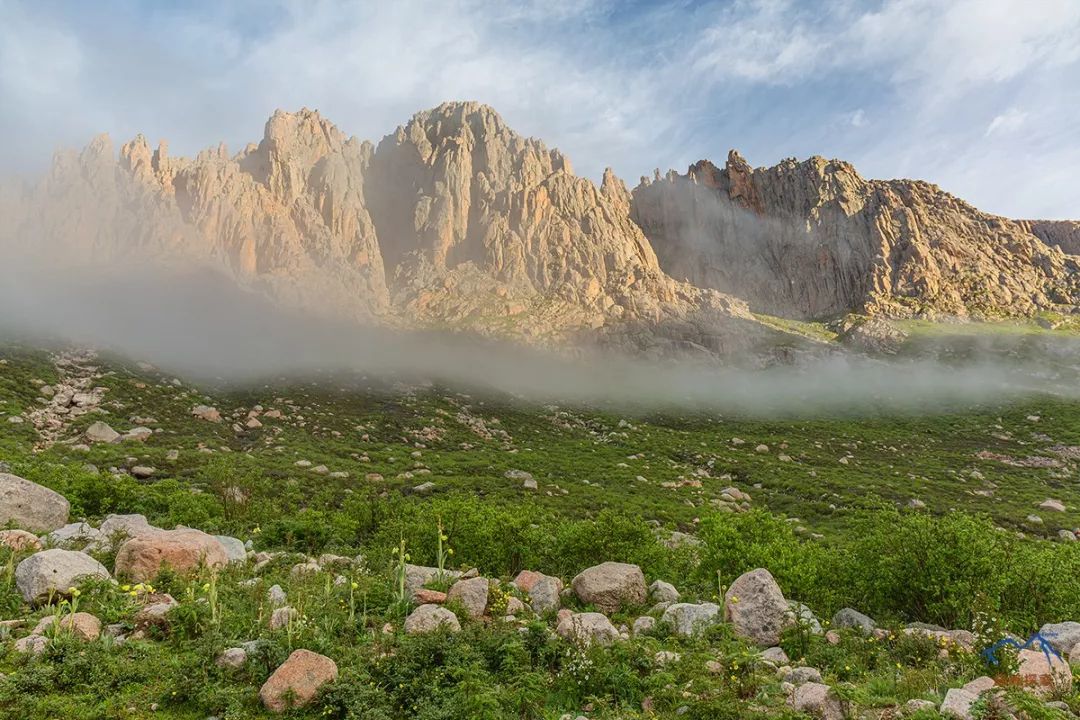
left=116, top=529, right=229, bottom=582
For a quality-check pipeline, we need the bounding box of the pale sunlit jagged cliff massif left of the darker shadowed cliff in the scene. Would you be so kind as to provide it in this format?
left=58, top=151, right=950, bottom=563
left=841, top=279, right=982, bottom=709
left=0, top=103, right=756, bottom=358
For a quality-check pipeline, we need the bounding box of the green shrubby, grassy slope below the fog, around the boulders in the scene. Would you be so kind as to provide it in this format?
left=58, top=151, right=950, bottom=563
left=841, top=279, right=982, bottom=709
left=0, top=343, right=1080, bottom=720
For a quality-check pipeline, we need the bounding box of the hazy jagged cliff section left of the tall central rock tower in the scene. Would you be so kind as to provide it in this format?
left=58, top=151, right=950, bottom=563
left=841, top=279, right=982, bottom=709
left=0, top=111, right=388, bottom=317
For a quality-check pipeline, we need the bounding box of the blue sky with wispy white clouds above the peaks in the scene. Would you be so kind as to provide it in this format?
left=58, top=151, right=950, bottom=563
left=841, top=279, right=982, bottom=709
left=0, top=0, right=1080, bottom=218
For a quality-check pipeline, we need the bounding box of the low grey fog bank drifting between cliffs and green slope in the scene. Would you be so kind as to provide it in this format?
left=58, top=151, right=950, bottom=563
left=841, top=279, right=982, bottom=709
left=0, top=257, right=1080, bottom=416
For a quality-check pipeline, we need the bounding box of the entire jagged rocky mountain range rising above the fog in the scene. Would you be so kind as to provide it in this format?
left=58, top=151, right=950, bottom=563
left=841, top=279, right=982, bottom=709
left=0, top=103, right=1080, bottom=354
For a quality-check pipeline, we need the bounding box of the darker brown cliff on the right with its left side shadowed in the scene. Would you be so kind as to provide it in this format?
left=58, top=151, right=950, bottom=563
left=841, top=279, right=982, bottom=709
left=632, top=151, right=1080, bottom=317
